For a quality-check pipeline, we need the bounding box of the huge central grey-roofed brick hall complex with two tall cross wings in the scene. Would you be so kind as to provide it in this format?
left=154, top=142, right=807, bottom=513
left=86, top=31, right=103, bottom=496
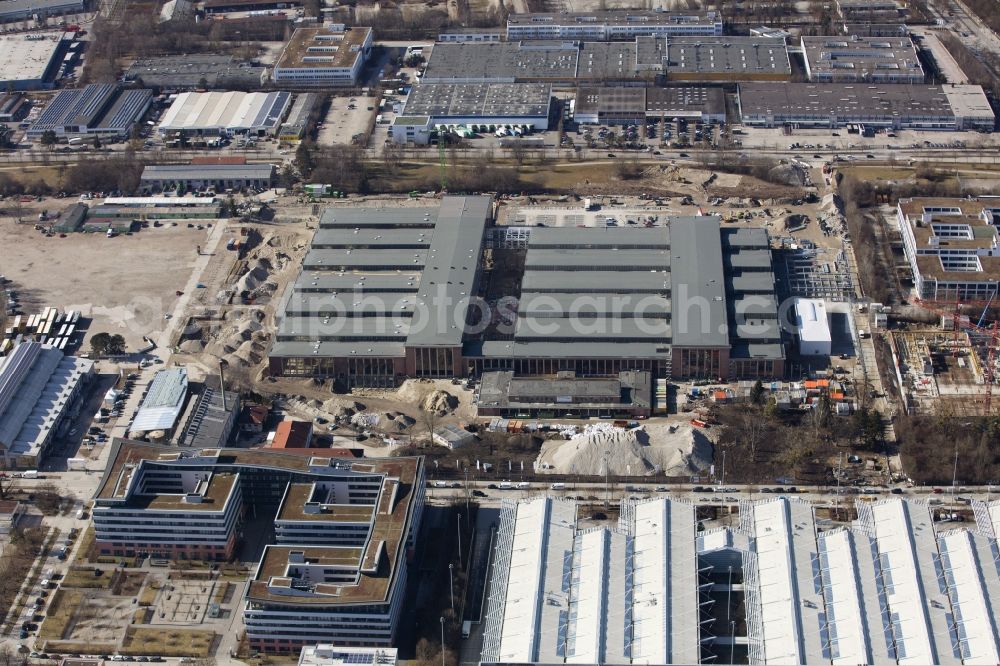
left=269, top=196, right=785, bottom=386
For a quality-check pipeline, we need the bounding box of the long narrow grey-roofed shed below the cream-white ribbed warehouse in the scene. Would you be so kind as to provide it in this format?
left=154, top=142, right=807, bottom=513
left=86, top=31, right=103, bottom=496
left=139, top=164, right=275, bottom=192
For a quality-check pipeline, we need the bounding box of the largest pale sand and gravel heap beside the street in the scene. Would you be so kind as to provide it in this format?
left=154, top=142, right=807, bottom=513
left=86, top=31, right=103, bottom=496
left=535, top=423, right=713, bottom=476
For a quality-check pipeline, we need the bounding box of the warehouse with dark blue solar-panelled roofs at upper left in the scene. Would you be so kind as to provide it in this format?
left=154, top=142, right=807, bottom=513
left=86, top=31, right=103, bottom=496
left=28, top=83, right=153, bottom=139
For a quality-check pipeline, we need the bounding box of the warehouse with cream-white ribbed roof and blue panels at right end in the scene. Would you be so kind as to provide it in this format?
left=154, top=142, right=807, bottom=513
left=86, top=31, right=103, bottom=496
left=157, top=92, right=292, bottom=137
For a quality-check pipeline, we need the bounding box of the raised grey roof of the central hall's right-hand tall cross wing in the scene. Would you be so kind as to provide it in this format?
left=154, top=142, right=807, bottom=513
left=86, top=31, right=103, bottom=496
left=670, top=216, right=729, bottom=347
